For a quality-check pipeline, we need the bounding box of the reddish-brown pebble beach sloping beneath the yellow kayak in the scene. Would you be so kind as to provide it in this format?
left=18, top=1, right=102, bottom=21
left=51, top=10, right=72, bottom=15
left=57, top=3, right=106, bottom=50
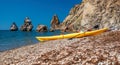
left=0, top=31, right=120, bottom=65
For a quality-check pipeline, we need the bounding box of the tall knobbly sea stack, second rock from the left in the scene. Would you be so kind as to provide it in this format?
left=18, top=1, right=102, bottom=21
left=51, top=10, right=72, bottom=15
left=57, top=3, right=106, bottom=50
left=20, top=17, right=33, bottom=31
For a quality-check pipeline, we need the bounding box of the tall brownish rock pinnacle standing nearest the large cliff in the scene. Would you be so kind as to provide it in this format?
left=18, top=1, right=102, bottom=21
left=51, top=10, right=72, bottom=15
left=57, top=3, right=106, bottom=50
left=50, top=15, right=60, bottom=31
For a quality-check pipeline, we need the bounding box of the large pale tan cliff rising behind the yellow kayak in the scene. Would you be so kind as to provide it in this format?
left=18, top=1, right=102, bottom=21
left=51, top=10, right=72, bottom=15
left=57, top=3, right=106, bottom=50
left=61, top=0, right=120, bottom=31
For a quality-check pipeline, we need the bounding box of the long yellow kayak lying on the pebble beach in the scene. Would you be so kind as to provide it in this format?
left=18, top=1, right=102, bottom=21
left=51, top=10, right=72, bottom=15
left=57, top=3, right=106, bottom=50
left=36, top=28, right=108, bottom=41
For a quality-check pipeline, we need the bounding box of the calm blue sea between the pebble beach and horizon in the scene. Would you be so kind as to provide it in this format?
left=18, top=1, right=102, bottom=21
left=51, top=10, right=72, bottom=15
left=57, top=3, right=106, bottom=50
left=0, top=30, right=60, bottom=52
